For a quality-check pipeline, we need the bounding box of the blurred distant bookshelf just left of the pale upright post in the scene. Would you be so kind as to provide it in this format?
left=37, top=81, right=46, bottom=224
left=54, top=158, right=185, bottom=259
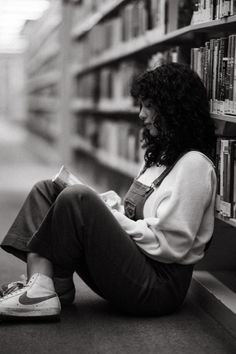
left=25, top=0, right=62, bottom=143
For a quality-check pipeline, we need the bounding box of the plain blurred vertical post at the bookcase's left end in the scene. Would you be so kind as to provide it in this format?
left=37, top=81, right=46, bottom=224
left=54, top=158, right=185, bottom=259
left=58, top=0, right=73, bottom=164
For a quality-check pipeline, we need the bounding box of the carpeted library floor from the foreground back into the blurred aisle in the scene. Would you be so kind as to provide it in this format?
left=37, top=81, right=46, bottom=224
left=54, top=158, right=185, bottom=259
left=0, top=119, right=236, bottom=354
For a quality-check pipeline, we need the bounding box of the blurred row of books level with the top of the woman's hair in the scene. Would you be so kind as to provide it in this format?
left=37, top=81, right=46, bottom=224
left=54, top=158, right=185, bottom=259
left=75, top=47, right=180, bottom=101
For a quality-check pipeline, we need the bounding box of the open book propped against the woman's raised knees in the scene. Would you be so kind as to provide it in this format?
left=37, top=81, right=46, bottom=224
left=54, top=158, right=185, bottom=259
left=52, top=166, right=121, bottom=210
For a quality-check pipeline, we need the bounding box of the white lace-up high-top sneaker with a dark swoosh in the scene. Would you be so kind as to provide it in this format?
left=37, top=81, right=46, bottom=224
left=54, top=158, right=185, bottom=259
left=0, top=273, right=61, bottom=318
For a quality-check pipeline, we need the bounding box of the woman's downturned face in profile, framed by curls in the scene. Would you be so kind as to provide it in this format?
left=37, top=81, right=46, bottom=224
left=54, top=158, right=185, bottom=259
left=139, top=99, right=158, bottom=137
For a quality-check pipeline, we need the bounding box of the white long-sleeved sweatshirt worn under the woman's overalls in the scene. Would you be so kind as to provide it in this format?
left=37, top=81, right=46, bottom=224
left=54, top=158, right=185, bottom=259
left=113, top=151, right=216, bottom=264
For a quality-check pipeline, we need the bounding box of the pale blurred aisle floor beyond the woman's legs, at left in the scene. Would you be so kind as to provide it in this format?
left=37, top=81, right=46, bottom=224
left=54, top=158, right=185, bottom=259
left=0, top=117, right=58, bottom=283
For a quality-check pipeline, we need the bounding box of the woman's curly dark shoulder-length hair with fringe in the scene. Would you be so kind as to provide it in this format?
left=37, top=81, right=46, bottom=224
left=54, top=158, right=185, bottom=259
left=131, top=63, right=216, bottom=167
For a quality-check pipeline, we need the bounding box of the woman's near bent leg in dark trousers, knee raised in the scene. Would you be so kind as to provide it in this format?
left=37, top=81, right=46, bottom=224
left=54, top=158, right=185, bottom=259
left=28, top=186, right=192, bottom=314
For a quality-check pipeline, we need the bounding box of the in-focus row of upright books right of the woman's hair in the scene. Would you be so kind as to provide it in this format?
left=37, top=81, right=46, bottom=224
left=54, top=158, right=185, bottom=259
left=191, top=34, right=236, bottom=115
